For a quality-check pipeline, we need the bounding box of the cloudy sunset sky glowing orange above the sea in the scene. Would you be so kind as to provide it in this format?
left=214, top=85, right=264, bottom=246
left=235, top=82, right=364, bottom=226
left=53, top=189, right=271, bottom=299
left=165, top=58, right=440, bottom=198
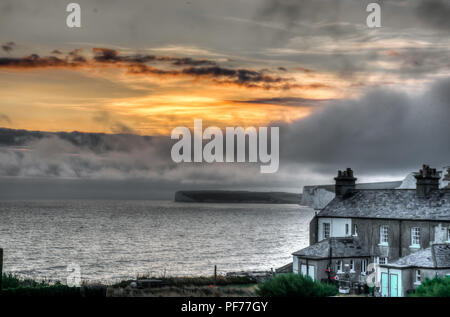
left=0, top=0, right=450, bottom=198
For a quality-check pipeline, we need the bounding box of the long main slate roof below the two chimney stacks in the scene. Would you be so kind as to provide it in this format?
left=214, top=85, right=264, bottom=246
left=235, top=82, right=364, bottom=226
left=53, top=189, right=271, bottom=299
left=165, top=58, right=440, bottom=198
left=318, top=189, right=450, bottom=221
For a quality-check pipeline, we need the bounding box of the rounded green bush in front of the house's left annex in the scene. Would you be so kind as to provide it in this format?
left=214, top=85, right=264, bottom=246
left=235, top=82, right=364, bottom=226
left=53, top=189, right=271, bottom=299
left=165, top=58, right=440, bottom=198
left=256, top=273, right=338, bottom=297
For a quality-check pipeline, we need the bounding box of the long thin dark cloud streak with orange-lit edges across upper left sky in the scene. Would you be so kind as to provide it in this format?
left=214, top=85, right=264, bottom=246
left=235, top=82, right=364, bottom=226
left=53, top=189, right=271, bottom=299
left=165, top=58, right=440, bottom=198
left=0, top=48, right=312, bottom=90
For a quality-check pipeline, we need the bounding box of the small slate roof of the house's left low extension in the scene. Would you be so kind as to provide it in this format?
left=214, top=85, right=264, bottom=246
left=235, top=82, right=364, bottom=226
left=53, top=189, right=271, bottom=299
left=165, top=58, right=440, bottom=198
left=292, top=237, right=370, bottom=259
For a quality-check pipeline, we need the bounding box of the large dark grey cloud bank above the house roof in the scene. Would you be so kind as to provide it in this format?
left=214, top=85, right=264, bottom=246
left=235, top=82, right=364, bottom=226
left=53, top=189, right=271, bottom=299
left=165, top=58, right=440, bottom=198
left=280, top=79, right=450, bottom=173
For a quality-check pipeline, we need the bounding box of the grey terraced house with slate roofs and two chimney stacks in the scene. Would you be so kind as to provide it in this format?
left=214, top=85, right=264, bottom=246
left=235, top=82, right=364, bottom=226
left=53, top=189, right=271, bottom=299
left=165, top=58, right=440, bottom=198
left=293, top=165, right=450, bottom=296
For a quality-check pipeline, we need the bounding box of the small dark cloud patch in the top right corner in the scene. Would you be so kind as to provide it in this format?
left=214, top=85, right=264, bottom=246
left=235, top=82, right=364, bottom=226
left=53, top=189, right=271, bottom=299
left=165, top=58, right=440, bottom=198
left=416, top=0, right=450, bottom=32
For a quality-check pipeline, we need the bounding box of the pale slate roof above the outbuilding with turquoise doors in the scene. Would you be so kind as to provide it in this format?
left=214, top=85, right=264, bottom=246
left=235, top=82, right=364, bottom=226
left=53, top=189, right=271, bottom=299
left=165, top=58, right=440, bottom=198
left=381, top=244, right=450, bottom=269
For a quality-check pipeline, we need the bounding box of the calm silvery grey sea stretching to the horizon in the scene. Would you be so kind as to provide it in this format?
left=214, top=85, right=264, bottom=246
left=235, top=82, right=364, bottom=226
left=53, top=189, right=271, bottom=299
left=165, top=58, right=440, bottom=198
left=0, top=200, right=314, bottom=282
